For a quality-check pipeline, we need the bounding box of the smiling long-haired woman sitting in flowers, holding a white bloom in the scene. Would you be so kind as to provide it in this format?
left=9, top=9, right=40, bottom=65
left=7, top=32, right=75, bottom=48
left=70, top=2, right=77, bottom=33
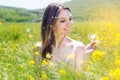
left=37, top=3, right=96, bottom=68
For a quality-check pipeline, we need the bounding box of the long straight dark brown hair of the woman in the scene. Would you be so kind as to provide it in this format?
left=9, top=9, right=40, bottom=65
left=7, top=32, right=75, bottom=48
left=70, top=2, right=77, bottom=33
left=41, top=3, right=71, bottom=59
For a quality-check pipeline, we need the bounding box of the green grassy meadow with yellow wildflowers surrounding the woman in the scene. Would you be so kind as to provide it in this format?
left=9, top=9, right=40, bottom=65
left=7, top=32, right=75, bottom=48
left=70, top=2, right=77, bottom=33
left=0, top=21, right=120, bottom=80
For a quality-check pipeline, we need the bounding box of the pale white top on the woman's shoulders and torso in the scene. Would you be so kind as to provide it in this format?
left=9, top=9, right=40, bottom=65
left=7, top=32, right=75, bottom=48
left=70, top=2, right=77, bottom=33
left=36, top=40, right=84, bottom=67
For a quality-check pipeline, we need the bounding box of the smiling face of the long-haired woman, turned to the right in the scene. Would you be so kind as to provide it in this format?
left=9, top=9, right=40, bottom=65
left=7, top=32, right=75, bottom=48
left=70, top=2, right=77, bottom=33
left=54, top=9, right=73, bottom=35
